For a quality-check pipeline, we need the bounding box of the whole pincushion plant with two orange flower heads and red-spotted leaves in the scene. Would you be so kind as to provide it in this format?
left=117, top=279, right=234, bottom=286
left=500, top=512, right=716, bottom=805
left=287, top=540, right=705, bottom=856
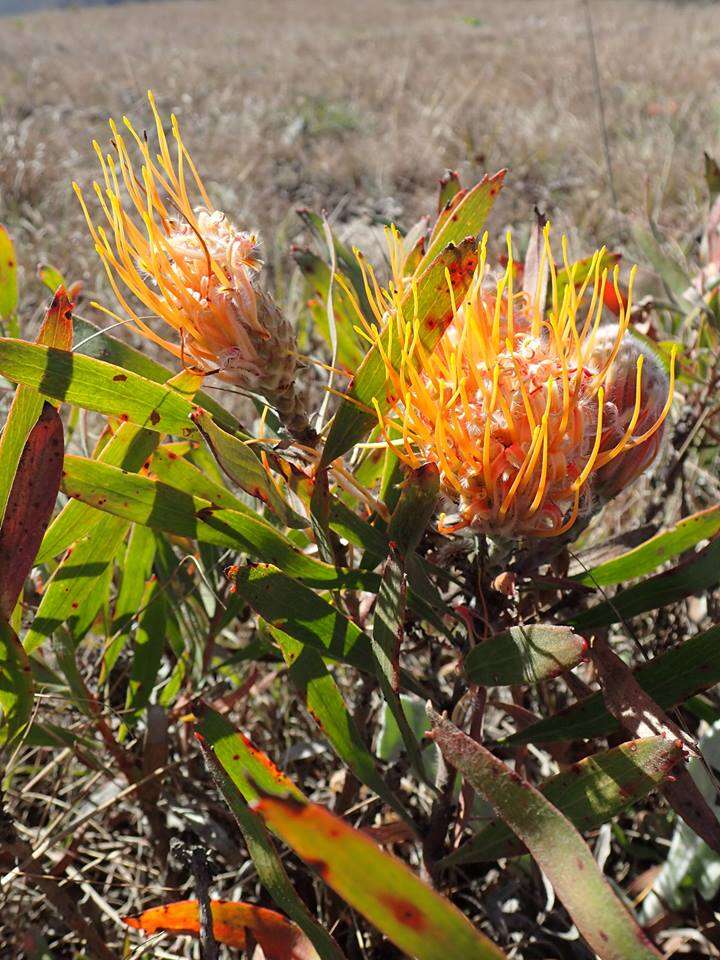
left=0, top=97, right=720, bottom=960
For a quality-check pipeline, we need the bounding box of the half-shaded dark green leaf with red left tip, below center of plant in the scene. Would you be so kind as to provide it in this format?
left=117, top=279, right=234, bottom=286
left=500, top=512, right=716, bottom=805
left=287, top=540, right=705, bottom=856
left=235, top=563, right=374, bottom=673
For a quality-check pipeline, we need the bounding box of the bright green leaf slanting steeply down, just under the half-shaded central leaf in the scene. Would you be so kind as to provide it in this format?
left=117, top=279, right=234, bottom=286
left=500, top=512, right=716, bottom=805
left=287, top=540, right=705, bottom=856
left=270, top=627, right=413, bottom=825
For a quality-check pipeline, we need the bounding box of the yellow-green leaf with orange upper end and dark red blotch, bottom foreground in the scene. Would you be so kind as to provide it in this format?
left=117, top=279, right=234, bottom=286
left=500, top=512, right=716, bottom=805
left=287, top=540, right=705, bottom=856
left=252, top=796, right=504, bottom=960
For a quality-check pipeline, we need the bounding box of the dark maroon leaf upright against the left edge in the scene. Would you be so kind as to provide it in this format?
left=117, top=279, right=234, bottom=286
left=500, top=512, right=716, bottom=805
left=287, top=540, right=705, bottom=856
left=0, top=403, right=63, bottom=620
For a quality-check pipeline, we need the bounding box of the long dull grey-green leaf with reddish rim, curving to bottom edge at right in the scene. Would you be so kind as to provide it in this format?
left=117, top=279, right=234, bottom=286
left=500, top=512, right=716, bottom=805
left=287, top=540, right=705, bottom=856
left=430, top=712, right=660, bottom=960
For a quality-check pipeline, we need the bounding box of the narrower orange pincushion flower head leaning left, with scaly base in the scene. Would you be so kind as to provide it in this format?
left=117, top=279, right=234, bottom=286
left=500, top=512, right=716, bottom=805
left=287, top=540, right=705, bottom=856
left=73, top=94, right=311, bottom=439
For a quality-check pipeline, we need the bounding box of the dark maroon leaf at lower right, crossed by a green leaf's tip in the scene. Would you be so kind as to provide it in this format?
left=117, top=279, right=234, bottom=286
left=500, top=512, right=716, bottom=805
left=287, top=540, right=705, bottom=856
left=592, top=639, right=720, bottom=853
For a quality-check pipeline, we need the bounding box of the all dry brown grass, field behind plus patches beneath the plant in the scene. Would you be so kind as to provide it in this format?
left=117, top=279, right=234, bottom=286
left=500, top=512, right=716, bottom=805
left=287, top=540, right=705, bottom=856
left=0, top=0, right=720, bottom=960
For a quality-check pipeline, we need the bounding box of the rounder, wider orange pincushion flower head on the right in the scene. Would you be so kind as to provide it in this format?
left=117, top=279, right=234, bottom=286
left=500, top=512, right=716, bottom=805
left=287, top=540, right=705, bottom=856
left=366, top=229, right=674, bottom=538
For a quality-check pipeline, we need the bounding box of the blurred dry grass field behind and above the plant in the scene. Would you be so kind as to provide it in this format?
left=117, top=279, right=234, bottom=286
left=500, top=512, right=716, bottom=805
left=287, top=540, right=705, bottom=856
left=0, top=0, right=720, bottom=321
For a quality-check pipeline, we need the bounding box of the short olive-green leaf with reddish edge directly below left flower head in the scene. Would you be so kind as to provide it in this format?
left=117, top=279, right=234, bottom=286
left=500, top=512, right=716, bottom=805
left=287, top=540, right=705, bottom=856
left=192, top=409, right=309, bottom=528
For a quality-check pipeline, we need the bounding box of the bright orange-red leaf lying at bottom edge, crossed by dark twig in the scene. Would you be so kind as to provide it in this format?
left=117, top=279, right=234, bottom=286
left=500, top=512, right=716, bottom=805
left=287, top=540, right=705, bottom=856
left=124, top=900, right=318, bottom=960
